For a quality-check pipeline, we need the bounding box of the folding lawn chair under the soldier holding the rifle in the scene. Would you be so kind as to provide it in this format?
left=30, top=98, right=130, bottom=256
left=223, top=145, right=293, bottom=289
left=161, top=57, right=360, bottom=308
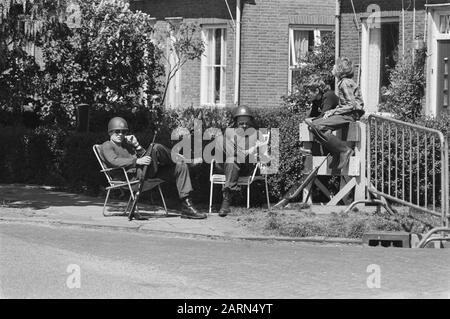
left=92, top=144, right=168, bottom=217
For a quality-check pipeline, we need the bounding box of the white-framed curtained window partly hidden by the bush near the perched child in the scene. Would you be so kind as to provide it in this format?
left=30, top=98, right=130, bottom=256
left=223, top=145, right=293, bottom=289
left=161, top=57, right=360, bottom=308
left=288, top=26, right=333, bottom=93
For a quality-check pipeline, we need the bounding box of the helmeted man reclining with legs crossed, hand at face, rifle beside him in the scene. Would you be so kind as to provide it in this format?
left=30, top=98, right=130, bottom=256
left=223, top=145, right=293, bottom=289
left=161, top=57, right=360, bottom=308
left=102, top=117, right=206, bottom=219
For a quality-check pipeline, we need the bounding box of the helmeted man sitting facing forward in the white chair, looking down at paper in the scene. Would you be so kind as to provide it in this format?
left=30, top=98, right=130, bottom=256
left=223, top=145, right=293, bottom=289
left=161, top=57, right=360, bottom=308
left=216, top=106, right=257, bottom=217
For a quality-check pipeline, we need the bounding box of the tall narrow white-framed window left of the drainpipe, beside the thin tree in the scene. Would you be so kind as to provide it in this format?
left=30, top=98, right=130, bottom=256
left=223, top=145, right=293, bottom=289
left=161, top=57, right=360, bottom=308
left=200, top=26, right=226, bottom=106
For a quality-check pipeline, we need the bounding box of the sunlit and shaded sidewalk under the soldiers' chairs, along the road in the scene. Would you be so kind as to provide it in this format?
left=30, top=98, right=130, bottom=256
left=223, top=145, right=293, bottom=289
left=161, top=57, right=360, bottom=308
left=0, top=184, right=360, bottom=244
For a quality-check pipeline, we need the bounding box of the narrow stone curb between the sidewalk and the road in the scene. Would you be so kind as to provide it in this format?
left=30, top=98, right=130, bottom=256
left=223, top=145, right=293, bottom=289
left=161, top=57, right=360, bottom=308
left=0, top=217, right=363, bottom=245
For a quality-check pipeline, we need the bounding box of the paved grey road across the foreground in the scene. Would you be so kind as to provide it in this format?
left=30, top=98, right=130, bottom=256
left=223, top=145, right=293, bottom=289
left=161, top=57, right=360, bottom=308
left=0, top=223, right=450, bottom=298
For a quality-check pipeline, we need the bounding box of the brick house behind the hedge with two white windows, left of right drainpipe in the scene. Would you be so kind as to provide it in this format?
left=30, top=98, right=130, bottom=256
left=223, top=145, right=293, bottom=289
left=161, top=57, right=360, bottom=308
left=128, top=0, right=336, bottom=108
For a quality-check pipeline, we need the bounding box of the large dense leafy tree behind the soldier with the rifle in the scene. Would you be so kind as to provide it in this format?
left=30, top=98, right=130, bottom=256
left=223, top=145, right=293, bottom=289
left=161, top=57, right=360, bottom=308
left=38, top=0, right=162, bottom=125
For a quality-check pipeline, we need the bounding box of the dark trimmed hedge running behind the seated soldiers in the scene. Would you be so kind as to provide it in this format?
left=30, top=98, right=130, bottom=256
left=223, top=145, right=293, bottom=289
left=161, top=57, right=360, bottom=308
left=0, top=107, right=450, bottom=208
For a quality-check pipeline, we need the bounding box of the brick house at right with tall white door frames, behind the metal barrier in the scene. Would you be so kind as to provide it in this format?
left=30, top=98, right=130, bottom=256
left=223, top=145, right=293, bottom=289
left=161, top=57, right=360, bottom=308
left=336, top=0, right=450, bottom=115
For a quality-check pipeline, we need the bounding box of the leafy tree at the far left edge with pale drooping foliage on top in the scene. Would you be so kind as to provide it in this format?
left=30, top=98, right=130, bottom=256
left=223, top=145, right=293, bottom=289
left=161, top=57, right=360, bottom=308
left=0, top=0, right=58, bottom=124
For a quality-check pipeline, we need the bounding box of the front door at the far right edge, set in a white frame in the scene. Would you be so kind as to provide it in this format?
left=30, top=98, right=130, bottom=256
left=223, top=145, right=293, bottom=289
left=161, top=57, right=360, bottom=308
left=436, top=40, right=450, bottom=114
